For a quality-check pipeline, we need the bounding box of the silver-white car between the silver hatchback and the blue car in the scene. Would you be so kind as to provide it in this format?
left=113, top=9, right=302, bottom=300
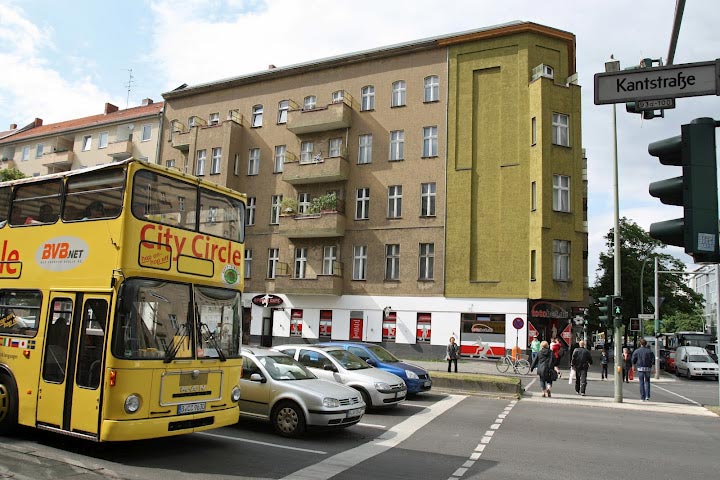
left=275, top=345, right=407, bottom=408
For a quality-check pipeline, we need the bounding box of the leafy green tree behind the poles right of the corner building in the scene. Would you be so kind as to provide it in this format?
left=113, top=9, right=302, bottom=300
left=590, top=217, right=704, bottom=336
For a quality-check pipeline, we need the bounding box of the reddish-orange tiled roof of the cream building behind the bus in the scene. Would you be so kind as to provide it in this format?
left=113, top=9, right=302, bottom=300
left=0, top=102, right=165, bottom=145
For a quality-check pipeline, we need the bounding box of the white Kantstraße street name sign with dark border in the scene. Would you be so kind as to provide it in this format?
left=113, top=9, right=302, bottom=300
left=595, top=59, right=720, bottom=104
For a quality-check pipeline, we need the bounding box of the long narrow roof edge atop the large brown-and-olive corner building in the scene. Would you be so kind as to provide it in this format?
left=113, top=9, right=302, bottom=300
left=162, top=20, right=575, bottom=100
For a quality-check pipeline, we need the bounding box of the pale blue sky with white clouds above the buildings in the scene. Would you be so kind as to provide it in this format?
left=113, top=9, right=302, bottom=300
left=0, top=0, right=720, bottom=284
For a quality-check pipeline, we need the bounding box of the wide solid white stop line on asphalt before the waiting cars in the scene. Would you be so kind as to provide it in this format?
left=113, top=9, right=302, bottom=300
left=285, top=395, right=466, bottom=480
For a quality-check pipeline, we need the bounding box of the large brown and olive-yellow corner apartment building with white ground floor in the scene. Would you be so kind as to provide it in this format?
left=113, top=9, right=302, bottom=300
left=161, top=22, right=587, bottom=357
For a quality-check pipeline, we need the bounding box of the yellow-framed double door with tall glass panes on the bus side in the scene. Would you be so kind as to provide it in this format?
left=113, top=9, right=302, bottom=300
left=37, top=292, right=109, bottom=436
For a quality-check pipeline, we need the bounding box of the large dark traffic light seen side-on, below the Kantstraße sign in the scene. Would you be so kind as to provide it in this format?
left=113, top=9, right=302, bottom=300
left=648, top=118, right=720, bottom=263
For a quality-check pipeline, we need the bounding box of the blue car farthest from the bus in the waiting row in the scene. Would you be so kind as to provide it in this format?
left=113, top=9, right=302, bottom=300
left=320, top=342, right=432, bottom=394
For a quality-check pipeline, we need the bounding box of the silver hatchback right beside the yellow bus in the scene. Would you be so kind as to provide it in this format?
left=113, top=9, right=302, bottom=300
left=240, top=348, right=365, bottom=437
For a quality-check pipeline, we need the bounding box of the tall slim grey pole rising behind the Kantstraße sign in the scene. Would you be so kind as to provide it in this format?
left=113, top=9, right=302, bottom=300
left=605, top=55, right=622, bottom=403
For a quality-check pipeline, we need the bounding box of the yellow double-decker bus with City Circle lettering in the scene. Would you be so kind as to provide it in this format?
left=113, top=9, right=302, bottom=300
left=0, top=159, right=246, bottom=441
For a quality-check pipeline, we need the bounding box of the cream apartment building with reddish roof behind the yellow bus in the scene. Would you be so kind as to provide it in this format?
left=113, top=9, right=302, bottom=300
left=0, top=98, right=163, bottom=177
